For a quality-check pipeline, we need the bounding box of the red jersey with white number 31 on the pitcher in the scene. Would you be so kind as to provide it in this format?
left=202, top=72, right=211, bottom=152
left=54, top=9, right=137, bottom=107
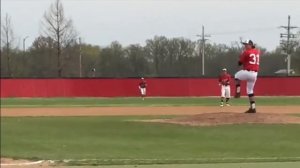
left=239, top=49, right=260, bottom=72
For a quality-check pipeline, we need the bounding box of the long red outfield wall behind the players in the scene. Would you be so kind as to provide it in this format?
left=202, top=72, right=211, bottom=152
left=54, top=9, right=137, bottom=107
left=1, top=77, right=300, bottom=97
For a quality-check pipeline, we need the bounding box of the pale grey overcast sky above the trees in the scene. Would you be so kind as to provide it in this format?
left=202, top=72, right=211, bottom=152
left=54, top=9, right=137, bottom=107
left=1, top=0, right=300, bottom=51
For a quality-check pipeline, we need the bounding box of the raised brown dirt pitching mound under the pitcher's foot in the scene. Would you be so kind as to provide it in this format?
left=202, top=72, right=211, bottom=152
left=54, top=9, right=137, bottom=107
left=152, top=112, right=300, bottom=126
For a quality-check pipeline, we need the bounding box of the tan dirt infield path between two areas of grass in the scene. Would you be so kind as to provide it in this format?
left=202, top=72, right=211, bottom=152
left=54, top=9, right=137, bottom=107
left=1, top=106, right=300, bottom=117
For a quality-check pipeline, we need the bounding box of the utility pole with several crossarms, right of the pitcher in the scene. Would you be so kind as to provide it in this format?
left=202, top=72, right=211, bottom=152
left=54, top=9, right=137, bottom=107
left=280, top=15, right=298, bottom=76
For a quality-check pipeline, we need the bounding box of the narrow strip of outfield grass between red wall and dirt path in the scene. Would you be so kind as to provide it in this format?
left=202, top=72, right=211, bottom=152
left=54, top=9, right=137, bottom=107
left=1, top=97, right=300, bottom=107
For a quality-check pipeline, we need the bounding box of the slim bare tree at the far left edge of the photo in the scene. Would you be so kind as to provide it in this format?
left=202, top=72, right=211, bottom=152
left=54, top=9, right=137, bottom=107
left=1, top=14, right=15, bottom=77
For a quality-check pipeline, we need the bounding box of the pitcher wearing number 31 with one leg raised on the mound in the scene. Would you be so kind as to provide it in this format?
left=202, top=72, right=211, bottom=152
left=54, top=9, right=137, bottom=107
left=234, top=40, right=260, bottom=113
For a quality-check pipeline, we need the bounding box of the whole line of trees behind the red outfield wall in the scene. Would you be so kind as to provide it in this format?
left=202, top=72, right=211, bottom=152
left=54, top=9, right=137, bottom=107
left=1, top=0, right=300, bottom=78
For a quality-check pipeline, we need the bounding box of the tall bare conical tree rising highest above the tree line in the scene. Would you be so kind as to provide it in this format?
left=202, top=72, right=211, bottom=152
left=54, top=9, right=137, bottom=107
left=42, top=0, right=77, bottom=77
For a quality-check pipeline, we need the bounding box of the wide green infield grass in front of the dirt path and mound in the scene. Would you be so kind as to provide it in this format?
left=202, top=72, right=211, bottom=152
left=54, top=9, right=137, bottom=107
left=1, top=117, right=300, bottom=165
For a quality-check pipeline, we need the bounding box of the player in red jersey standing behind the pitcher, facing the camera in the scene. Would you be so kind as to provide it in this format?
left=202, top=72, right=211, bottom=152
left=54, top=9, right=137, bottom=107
left=219, top=68, right=231, bottom=107
